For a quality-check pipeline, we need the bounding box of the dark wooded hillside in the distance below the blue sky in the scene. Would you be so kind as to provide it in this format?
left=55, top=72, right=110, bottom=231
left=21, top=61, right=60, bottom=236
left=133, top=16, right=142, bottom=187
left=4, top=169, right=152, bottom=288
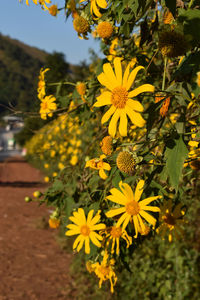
left=0, top=34, right=48, bottom=114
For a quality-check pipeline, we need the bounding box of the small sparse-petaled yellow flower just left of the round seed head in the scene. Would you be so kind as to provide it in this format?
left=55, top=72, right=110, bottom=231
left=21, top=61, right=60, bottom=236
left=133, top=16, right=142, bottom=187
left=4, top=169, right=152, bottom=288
left=85, top=155, right=111, bottom=179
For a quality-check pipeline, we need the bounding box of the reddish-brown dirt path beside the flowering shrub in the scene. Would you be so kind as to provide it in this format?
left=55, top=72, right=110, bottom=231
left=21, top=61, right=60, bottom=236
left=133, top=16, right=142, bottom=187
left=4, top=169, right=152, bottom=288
left=0, top=160, right=73, bottom=300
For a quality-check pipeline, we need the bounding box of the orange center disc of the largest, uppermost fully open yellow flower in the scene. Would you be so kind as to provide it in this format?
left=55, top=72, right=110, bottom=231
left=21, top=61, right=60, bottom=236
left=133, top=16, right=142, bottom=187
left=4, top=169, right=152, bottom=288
left=111, top=86, right=128, bottom=108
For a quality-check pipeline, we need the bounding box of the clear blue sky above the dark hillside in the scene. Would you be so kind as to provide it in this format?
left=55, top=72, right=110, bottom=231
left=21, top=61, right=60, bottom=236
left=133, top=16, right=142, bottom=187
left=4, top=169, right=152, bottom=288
left=0, top=0, right=102, bottom=64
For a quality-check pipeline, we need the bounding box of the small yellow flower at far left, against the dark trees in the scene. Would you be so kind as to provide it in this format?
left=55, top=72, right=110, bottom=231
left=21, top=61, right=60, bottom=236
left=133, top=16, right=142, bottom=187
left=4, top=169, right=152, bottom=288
left=40, top=95, right=57, bottom=120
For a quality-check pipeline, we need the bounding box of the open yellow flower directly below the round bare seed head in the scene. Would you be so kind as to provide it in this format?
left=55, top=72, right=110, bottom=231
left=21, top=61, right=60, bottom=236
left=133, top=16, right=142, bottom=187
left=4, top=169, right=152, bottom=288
left=106, top=180, right=162, bottom=238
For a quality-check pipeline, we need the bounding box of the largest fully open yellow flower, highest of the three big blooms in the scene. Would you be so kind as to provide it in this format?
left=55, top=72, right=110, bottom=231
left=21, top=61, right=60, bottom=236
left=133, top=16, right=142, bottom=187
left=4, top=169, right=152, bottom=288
left=94, top=57, right=154, bottom=137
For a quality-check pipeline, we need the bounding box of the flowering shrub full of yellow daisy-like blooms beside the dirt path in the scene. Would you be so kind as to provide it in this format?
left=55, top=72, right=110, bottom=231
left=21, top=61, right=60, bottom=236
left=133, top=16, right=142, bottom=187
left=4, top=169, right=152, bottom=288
left=20, top=0, right=200, bottom=299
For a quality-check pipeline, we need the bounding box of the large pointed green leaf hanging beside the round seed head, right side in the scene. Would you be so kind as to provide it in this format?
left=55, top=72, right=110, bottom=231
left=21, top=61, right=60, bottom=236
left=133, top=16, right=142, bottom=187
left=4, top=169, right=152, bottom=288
left=165, top=135, right=188, bottom=191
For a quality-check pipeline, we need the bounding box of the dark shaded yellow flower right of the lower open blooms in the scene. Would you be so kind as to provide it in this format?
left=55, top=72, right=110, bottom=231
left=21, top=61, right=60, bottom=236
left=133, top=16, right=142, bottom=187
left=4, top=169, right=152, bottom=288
left=157, top=199, right=185, bottom=242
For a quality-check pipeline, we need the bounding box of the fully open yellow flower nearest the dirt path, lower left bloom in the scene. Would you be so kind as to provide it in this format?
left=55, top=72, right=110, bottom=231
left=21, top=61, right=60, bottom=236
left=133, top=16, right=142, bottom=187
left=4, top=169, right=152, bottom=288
left=65, top=208, right=106, bottom=254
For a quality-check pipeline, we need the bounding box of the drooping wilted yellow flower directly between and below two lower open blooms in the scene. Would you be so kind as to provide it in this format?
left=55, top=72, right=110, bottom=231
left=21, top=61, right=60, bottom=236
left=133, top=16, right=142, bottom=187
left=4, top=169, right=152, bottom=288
left=102, top=226, right=132, bottom=255
